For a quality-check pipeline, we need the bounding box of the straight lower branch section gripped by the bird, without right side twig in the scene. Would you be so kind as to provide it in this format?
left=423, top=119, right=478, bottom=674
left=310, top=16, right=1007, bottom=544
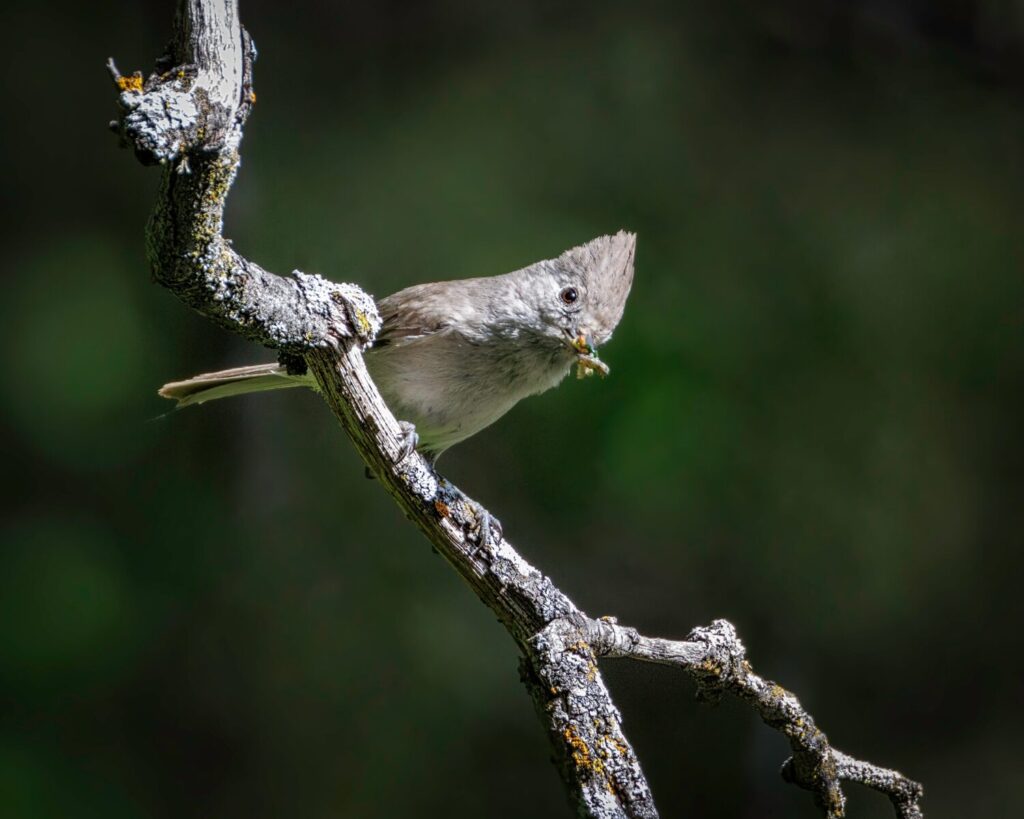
left=306, top=344, right=657, bottom=819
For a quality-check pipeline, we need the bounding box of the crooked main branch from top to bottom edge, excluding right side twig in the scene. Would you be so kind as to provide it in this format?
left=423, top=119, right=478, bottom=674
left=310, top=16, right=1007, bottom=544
left=111, top=0, right=656, bottom=819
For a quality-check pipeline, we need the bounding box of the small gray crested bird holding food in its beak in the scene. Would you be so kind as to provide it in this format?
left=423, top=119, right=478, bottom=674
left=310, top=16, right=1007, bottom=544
left=160, top=231, right=636, bottom=464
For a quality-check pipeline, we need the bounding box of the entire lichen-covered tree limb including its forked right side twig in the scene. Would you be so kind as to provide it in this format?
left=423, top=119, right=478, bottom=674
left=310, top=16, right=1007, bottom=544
left=109, top=0, right=922, bottom=819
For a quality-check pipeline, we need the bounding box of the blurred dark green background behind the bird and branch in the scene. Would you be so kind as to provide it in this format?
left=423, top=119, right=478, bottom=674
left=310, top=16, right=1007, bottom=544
left=0, top=0, right=1024, bottom=819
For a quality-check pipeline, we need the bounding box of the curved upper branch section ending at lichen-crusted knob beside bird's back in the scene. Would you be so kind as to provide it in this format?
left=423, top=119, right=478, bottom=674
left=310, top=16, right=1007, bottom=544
left=108, top=0, right=352, bottom=353
